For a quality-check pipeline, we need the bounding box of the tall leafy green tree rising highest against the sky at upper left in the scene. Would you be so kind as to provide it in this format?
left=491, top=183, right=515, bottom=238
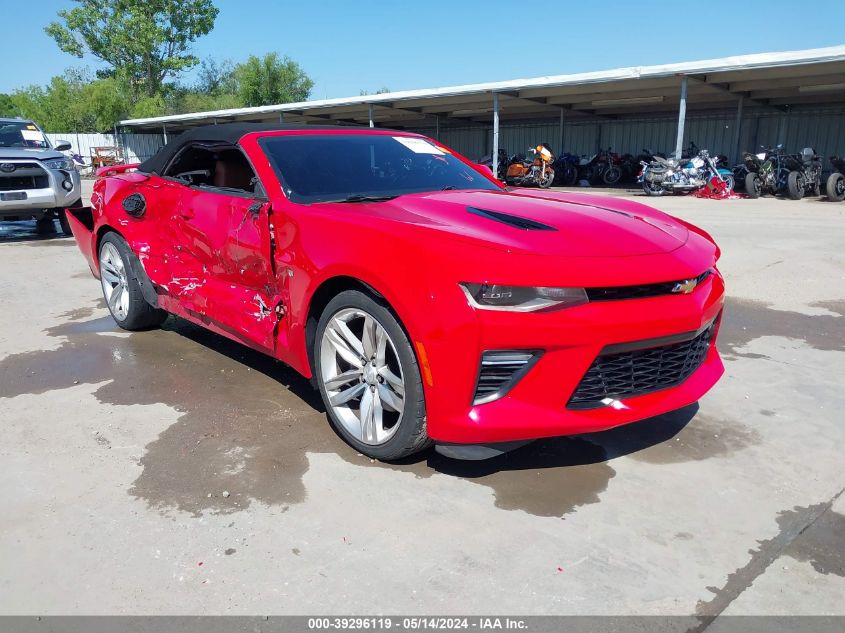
left=44, top=0, right=218, bottom=97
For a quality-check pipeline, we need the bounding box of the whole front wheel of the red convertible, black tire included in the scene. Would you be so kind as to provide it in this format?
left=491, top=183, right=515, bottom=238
left=314, top=290, right=430, bottom=460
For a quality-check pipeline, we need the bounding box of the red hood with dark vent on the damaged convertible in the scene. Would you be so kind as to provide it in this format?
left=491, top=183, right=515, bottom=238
left=352, top=190, right=689, bottom=257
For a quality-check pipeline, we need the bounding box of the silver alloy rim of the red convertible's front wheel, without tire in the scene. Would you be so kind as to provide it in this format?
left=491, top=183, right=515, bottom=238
left=320, top=308, right=405, bottom=446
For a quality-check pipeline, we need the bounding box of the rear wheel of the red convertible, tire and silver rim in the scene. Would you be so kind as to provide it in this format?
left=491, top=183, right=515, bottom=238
left=100, top=233, right=167, bottom=331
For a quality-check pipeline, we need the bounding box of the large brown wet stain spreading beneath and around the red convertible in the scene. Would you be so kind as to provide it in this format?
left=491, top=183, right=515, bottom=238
left=0, top=302, right=756, bottom=517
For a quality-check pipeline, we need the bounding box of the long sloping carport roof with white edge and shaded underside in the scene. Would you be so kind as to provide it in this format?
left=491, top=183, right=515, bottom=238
left=120, top=45, right=845, bottom=129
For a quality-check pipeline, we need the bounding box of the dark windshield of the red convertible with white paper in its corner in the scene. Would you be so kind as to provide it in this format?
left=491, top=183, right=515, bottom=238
left=261, top=134, right=499, bottom=204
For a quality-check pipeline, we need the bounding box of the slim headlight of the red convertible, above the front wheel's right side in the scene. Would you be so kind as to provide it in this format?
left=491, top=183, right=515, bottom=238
left=460, top=283, right=589, bottom=312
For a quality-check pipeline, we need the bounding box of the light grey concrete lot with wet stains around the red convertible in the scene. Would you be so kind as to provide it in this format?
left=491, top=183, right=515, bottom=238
left=0, top=180, right=845, bottom=616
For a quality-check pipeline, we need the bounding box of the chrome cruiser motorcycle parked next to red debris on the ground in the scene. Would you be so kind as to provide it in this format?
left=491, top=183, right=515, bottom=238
left=639, top=149, right=734, bottom=196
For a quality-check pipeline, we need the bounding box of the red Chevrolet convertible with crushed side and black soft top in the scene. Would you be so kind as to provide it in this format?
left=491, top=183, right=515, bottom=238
left=69, top=124, right=724, bottom=460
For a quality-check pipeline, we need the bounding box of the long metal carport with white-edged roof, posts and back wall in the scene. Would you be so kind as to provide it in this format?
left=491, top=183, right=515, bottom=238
left=120, top=45, right=845, bottom=174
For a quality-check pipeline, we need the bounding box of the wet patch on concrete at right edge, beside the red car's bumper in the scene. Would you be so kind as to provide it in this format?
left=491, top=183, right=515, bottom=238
left=719, top=297, right=845, bottom=359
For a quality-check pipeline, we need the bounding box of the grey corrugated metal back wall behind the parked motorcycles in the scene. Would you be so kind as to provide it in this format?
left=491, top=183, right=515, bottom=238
left=417, top=107, right=845, bottom=164
